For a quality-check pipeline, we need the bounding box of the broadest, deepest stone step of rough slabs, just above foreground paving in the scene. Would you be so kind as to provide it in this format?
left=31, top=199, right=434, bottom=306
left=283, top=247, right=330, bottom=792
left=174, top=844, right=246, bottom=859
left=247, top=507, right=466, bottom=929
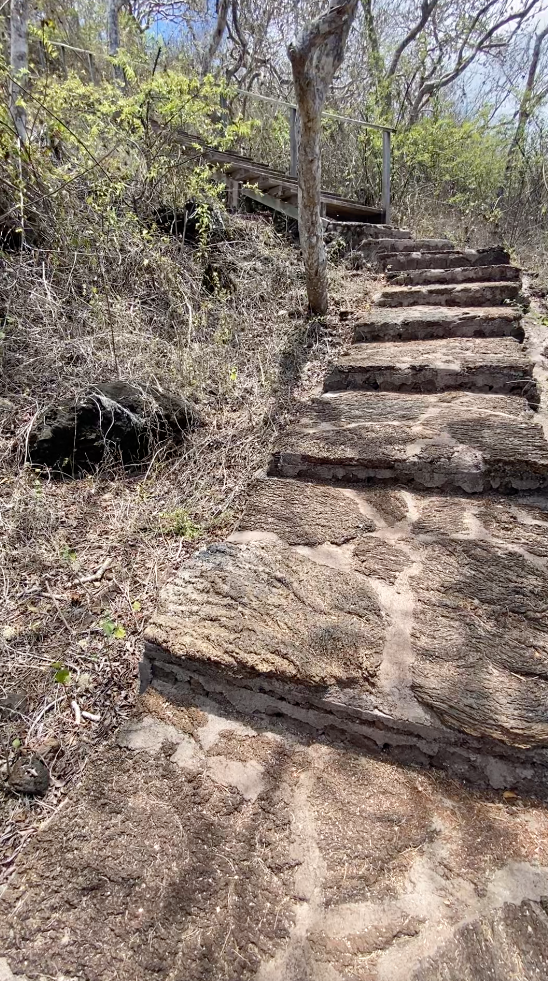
left=145, top=480, right=548, bottom=792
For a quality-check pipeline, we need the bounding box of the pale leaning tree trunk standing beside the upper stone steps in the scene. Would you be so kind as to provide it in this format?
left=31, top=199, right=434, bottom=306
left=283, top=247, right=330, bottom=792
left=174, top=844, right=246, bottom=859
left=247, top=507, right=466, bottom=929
left=288, top=0, right=358, bottom=316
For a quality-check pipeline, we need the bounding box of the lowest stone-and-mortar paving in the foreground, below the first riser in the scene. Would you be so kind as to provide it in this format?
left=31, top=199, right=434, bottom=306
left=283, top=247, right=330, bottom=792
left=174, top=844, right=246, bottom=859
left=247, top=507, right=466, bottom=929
left=0, top=693, right=548, bottom=981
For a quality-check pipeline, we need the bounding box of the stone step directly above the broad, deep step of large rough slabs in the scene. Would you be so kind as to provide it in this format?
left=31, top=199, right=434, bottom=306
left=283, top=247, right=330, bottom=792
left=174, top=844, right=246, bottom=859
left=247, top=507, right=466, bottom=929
left=271, top=392, right=548, bottom=493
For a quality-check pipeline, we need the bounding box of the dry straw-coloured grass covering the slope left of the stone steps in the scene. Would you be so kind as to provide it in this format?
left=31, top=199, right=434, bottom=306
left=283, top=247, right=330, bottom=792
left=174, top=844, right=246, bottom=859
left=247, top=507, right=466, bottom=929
left=0, top=205, right=367, bottom=875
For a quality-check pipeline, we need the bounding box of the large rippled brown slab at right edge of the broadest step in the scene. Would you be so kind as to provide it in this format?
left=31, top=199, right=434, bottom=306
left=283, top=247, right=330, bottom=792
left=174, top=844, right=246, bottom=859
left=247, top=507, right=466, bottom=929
left=412, top=526, right=548, bottom=746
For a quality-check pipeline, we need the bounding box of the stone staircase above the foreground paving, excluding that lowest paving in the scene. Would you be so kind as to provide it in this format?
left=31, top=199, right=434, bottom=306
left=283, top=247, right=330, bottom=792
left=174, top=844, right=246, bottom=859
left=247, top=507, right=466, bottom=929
left=143, top=231, right=548, bottom=792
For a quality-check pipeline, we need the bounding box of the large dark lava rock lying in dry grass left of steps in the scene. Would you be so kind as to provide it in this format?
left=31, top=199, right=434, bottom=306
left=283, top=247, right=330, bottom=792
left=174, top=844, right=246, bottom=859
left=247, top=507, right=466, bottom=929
left=28, top=381, right=199, bottom=476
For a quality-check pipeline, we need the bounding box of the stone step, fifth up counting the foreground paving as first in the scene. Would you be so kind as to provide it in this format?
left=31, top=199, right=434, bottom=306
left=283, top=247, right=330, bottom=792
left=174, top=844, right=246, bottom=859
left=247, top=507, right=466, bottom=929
left=354, top=306, right=523, bottom=341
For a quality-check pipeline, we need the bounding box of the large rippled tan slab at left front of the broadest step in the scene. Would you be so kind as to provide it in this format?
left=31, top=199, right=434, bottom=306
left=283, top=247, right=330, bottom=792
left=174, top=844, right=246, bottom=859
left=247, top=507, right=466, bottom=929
left=147, top=542, right=384, bottom=688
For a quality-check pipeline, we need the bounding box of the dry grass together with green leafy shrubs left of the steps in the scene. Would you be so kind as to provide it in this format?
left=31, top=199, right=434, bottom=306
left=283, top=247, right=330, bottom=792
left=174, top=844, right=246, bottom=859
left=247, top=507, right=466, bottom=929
left=0, top=59, right=376, bottom=875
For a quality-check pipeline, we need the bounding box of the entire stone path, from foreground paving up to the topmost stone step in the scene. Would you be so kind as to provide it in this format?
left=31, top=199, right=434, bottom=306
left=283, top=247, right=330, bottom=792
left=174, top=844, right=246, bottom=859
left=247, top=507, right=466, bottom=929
left=0, top=232, right=548, bottom=981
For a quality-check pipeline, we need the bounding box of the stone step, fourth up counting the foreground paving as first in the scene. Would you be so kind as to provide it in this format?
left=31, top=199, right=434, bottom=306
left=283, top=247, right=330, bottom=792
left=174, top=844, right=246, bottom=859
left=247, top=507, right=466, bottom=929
left=324, top=337, right=539, bottom=405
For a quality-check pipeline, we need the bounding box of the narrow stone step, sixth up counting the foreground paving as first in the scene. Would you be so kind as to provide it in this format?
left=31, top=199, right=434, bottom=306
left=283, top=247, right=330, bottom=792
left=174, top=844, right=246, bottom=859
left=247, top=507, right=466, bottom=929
left=374, top=282, right=521, bottom=307
